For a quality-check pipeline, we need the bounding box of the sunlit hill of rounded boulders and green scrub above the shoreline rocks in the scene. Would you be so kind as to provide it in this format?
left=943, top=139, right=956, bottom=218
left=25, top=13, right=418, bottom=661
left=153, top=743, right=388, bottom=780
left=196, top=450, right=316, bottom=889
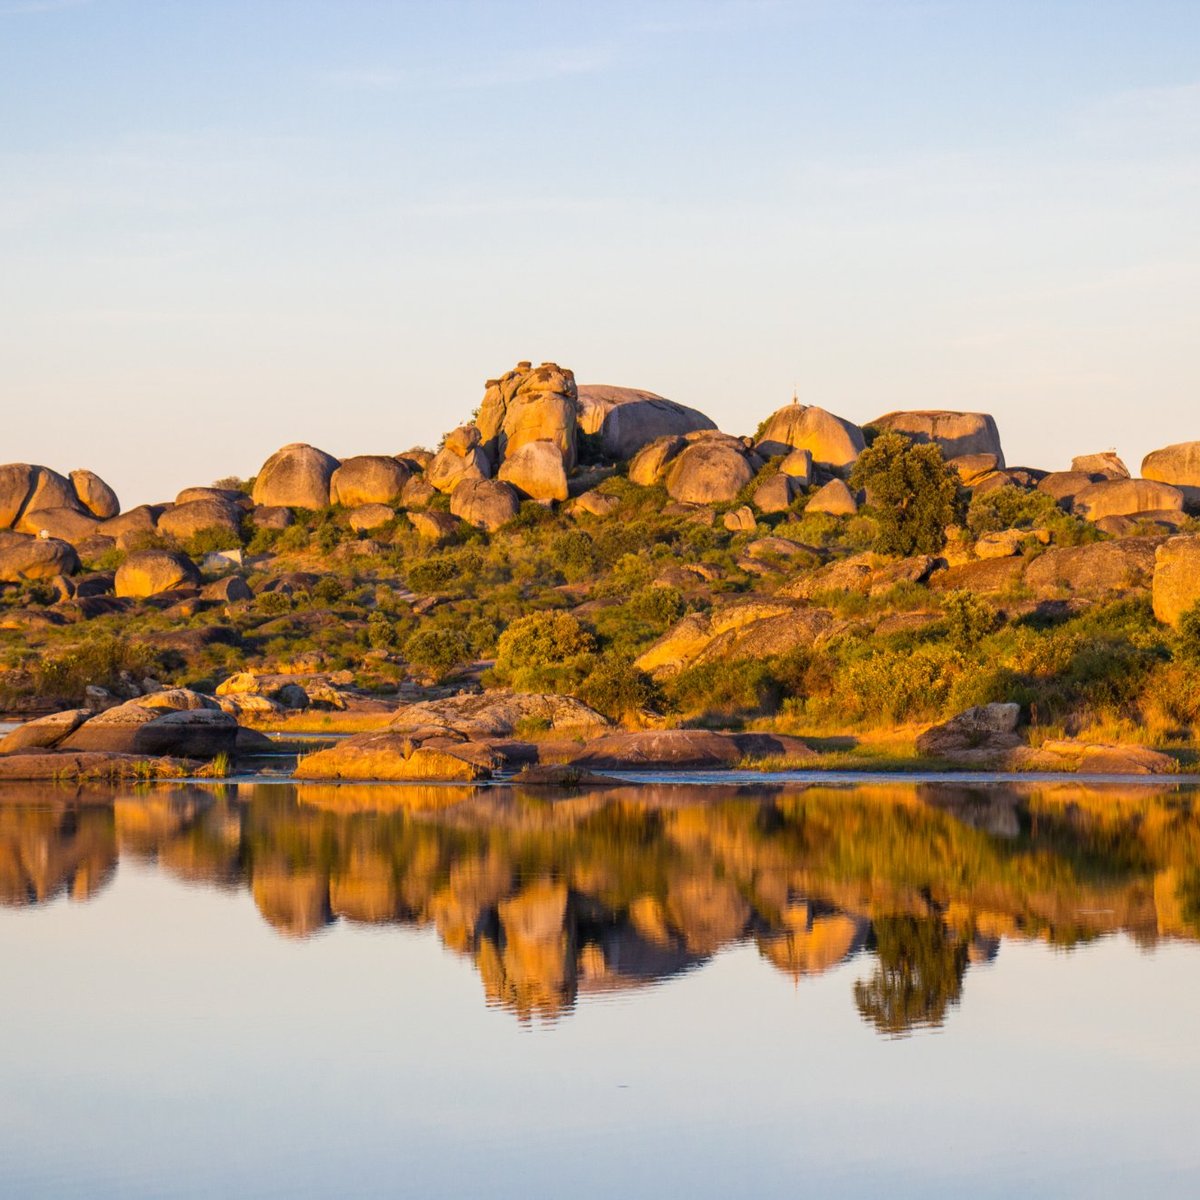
left=0, top=352, right=1200, bottom=761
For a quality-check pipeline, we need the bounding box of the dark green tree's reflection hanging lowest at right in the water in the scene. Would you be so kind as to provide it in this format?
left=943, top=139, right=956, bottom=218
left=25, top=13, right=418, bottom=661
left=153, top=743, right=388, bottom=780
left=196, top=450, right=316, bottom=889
left=854, top=917, right=967, bottom=1034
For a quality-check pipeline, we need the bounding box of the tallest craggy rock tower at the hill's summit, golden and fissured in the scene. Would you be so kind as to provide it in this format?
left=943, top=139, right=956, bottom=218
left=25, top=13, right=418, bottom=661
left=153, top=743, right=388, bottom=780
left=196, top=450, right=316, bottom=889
left=478, top=362, right=578, bottom=470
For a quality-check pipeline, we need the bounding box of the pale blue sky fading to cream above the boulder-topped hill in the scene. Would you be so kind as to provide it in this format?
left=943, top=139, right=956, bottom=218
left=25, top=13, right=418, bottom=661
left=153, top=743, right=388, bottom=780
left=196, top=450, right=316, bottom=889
left=0, top=0, right=1200, bottom=504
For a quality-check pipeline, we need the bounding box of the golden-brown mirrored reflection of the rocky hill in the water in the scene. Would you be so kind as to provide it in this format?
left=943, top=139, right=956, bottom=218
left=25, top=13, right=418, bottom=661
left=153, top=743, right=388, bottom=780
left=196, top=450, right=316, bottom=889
left=0, top=785, right=1200, bottom=1036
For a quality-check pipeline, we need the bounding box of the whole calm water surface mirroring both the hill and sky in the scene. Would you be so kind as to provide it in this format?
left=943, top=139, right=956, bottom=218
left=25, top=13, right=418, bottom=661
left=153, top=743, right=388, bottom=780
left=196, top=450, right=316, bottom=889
left=0, top=782, right=1200, bottom=1198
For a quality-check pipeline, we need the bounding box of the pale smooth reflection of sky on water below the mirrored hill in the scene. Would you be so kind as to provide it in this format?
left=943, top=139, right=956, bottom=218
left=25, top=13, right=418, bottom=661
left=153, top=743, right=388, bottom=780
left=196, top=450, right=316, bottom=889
left=0, top=782, right=1200, bottom=1196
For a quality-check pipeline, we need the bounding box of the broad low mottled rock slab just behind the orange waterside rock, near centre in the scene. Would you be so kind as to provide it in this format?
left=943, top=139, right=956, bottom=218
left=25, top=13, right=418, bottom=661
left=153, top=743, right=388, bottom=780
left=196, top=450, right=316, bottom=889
left=390, top=691, right=611, bottom=738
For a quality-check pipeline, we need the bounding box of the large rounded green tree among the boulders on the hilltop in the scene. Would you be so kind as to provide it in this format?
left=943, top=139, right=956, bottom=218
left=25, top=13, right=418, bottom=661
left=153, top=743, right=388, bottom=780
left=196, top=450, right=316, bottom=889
left=850, top=433, right=961, bottom=554
